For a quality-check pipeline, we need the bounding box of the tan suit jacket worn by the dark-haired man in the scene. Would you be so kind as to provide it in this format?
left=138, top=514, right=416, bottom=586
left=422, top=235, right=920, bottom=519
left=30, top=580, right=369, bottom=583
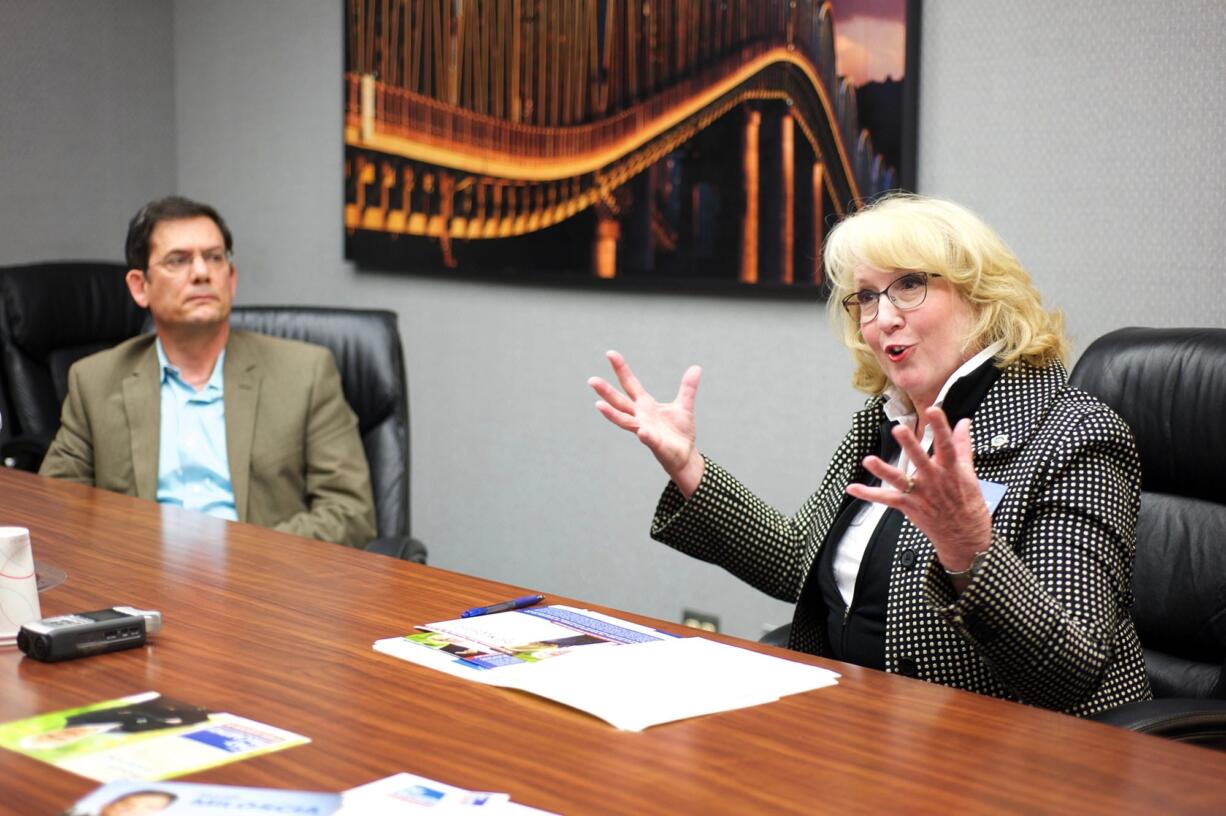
left=39, top=331, right=375, bottom=546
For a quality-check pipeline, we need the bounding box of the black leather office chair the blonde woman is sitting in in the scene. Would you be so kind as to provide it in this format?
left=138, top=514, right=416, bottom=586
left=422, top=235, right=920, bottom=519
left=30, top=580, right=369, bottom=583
left=1072, top=328, right=1226, bottom=749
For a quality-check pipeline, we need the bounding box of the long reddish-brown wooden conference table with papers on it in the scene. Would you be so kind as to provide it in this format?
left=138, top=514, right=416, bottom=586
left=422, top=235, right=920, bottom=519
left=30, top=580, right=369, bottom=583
left=0, top=468, right=1226, bottom=816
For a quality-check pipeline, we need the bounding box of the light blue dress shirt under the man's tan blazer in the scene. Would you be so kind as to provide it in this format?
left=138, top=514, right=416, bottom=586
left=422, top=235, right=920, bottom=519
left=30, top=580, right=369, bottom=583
left=157, top=339, right=238, bottom=521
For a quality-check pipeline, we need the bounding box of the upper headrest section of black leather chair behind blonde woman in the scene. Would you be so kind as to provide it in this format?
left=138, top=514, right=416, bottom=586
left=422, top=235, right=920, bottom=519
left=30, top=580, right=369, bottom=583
left=1072, top=327, right=1226, bottom=504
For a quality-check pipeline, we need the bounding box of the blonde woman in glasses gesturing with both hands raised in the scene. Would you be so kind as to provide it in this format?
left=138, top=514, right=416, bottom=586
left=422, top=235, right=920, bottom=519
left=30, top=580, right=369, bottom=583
left=588, top=195, right=1151, bottom=716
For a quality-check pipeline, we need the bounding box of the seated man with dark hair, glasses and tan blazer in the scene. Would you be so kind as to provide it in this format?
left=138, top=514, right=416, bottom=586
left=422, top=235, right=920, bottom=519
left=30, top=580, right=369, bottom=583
left=39, top=197, right=375, bottom=546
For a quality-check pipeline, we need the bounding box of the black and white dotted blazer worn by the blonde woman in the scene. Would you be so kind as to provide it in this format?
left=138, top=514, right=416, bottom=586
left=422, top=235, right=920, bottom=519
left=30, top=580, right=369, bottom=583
left=651, top=363, right=1151, bottom=716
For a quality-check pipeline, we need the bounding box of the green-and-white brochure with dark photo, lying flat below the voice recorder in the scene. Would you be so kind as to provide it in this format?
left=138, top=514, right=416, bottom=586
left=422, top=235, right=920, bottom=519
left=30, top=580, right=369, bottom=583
left=0, top=691, right=310, bottom=782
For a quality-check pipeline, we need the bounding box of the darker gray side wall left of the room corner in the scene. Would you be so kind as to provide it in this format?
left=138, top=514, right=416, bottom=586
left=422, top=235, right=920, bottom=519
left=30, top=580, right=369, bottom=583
left=0, top=0, right=175, bottom=263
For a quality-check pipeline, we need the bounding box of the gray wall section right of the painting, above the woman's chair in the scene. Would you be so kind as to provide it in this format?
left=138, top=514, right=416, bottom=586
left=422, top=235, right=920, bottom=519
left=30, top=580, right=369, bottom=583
left=920, top=0, right=1226, bottom=349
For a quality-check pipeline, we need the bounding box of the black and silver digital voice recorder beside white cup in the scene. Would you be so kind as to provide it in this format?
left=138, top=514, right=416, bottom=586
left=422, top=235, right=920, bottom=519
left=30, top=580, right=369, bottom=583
left=17, top=606, right=162, bottom=663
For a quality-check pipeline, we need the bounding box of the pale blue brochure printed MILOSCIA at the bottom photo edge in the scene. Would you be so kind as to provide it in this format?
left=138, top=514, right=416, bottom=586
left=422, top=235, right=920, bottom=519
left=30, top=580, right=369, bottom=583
left=63, top=782, right=341, bottom=816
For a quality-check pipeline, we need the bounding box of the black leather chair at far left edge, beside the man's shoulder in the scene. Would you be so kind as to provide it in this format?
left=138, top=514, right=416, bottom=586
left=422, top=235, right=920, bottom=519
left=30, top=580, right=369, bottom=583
left=0, top=261, right=145, bottom=470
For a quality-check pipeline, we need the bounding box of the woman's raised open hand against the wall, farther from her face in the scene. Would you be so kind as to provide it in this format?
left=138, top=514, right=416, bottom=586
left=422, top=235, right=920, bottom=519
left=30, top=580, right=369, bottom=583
left=587, top=352, right=704, bottom=497
